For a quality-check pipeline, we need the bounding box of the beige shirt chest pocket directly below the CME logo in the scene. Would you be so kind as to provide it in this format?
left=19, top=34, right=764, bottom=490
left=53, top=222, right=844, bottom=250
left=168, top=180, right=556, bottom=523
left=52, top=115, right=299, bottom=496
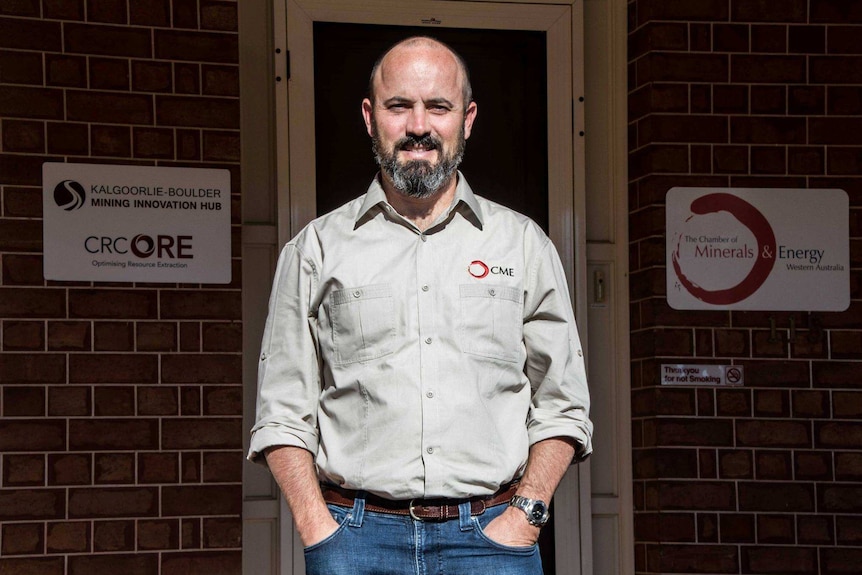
left=459, top=284, right=524, bottom=361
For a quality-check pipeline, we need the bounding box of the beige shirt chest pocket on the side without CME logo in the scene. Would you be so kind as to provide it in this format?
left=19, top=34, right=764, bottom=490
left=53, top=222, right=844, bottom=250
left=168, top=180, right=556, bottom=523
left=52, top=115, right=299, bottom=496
left=330, top=284, right=395, bottom=365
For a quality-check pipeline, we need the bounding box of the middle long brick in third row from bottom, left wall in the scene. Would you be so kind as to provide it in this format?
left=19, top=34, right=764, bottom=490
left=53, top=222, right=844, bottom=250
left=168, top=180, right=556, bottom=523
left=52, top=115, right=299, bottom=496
left=69, top=487, right=159, bottom=519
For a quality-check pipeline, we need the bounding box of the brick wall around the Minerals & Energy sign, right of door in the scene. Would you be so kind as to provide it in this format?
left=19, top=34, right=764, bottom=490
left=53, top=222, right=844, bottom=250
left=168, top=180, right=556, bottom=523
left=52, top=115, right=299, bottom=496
left=628, top=0, right=862, bottom=575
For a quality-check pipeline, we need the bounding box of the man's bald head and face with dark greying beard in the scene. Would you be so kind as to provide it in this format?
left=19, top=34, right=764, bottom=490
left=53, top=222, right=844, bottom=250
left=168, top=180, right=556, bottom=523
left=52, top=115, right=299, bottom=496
left=362, top=42, right=476, bottom=198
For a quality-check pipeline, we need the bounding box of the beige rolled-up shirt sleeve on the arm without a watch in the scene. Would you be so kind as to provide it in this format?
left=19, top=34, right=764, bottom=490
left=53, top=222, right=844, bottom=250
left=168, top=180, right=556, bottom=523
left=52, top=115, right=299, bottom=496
left=248, top=244, right=320, bottom=464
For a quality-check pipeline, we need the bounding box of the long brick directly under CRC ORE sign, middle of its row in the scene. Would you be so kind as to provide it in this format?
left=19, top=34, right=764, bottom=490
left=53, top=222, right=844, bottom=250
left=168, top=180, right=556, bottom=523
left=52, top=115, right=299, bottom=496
left=69, top=289, right=158, bottom=320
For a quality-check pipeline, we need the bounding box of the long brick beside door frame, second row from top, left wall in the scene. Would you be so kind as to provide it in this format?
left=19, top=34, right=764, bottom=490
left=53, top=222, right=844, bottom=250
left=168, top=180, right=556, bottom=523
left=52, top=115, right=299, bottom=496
left=155, top=30, right=239, bottom=64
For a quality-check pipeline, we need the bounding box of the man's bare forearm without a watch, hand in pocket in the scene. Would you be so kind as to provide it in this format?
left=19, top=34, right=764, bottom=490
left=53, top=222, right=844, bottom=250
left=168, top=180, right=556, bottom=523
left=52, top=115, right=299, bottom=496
left=266, top=446, right=334, bottom=546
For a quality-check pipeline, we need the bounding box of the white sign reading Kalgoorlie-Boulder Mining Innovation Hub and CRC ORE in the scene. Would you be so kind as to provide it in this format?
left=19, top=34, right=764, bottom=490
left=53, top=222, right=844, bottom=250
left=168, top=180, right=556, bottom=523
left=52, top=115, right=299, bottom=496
left=42, top=162, right=231, bottom=283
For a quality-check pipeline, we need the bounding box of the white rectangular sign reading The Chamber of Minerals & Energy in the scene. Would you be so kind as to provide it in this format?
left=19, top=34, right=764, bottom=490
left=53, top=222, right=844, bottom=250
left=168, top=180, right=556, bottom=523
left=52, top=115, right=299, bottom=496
left=665, top=187, right=850, bottom=311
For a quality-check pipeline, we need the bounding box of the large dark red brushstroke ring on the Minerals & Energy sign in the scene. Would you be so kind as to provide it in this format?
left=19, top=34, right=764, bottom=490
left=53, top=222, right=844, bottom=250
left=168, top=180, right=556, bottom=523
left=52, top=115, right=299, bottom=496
left=671, top=193, right=775, bottom=305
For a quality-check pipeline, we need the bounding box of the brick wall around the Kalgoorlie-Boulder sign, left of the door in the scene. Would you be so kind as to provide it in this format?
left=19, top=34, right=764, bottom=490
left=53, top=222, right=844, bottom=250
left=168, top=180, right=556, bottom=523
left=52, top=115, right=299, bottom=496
left=0, top=0, right=243, bottom=575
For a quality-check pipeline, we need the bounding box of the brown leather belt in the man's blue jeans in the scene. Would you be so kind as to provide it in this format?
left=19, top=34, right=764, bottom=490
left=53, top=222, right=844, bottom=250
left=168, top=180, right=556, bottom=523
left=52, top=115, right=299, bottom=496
left=320, top=482, right=518, bottom=521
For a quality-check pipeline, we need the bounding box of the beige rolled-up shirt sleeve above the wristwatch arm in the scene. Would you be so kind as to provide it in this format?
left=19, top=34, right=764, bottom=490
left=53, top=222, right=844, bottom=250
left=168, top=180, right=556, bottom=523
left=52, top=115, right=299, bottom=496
left=524, top=241, right=593, bottom=461
